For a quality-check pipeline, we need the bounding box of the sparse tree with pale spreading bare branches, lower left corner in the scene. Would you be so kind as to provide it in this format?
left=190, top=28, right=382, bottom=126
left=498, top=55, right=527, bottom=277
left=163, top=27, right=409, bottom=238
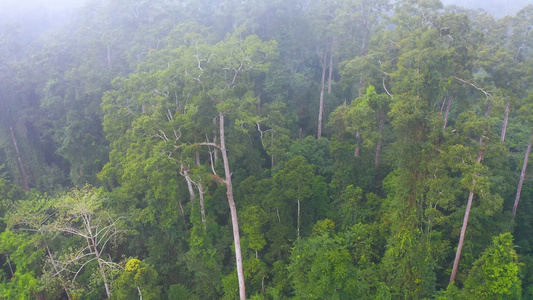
left=7, top=186, right=125, bottom=298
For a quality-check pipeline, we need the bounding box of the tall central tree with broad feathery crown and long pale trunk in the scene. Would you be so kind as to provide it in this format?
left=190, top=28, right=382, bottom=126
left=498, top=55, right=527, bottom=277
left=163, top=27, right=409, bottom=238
left=104, top=24, right=277, bottom=299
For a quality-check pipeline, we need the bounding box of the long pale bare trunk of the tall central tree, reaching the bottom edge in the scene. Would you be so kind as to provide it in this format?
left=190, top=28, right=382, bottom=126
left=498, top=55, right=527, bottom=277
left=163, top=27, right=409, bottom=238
left=219, top=113, right=246, bottom=300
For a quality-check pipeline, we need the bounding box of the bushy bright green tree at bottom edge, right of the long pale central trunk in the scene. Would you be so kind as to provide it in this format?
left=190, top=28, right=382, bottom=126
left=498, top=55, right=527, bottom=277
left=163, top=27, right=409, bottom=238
left=288, top=219, right=379, bottom=299
